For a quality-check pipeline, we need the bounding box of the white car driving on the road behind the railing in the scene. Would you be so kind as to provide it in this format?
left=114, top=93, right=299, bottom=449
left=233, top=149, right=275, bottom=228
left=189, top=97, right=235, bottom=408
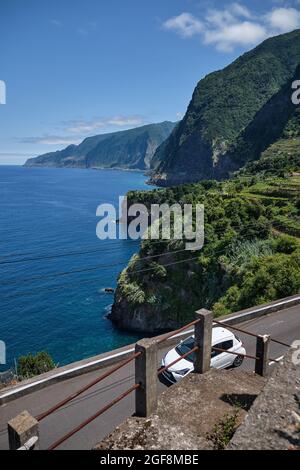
left=161, top=327, right=246, bottom=383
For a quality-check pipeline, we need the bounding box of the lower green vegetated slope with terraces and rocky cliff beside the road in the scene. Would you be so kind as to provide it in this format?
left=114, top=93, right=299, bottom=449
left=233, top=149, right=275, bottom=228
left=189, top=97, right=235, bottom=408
left=111, top=176, right=300, bottom=331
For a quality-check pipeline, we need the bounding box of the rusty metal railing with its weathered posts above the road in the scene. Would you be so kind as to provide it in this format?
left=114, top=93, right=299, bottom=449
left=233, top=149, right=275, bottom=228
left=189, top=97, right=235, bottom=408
left=9, top=309, right=289, bottom=450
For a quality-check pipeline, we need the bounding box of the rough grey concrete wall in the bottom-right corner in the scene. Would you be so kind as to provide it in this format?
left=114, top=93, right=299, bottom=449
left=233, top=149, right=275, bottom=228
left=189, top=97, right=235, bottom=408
left=228, top=350, right=300, bottom=450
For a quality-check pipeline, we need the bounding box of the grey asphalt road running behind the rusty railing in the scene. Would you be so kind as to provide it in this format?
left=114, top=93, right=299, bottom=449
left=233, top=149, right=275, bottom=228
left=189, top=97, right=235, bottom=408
left=0, top=306, right=300, bottom=450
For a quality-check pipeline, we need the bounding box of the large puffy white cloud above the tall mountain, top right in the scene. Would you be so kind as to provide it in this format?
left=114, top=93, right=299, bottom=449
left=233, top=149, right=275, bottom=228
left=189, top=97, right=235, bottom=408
left=163, top=0, right=300, bottom=52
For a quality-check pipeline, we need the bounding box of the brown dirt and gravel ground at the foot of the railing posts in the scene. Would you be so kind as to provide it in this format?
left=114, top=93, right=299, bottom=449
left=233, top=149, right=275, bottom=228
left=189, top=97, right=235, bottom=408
left=95, top=369, right=265, bottom=450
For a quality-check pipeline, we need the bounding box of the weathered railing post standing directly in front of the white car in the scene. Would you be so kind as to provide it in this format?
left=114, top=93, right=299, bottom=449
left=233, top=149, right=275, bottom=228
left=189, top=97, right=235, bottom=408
left=194, top=308, right=213, bottom=374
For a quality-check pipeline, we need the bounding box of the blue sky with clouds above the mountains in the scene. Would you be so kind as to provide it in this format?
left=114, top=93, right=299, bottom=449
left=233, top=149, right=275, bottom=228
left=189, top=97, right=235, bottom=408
left=0, top=0, right=300, bottom=164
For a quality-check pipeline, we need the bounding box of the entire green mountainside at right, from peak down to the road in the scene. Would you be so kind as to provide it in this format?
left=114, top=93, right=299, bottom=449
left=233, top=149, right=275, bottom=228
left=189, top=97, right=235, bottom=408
left=110, top=31, right=300, bottom=333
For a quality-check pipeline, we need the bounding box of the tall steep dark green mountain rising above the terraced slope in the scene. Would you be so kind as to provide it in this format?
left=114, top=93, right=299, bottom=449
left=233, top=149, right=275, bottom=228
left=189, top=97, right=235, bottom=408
left=152, top=30, right=300, bottom=185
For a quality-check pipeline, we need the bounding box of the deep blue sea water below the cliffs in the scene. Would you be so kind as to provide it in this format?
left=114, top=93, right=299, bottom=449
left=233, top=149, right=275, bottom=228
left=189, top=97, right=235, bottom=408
left=0, top=166, right=149, bottom=366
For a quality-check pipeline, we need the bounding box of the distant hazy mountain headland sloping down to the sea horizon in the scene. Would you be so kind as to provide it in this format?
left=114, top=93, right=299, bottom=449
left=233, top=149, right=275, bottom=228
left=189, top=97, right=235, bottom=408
left=25, top=121, right=175, bottom=170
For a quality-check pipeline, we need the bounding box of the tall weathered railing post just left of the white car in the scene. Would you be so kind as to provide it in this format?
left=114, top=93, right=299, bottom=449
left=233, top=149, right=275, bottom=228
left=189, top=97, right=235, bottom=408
left=135, top=339, right=157, bottom=418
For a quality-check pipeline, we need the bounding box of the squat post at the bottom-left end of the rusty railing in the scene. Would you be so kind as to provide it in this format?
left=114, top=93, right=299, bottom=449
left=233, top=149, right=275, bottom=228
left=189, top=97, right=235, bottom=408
left=7, top=411, right=39, bottom=450
